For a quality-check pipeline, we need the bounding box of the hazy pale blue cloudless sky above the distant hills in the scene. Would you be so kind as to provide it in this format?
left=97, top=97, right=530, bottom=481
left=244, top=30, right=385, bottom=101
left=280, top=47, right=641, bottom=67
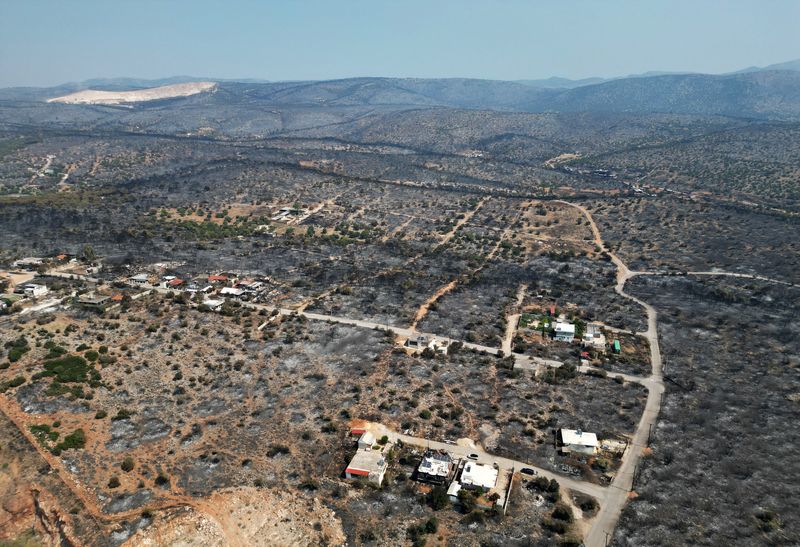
left=0, top=0, right=800, bottom=87
